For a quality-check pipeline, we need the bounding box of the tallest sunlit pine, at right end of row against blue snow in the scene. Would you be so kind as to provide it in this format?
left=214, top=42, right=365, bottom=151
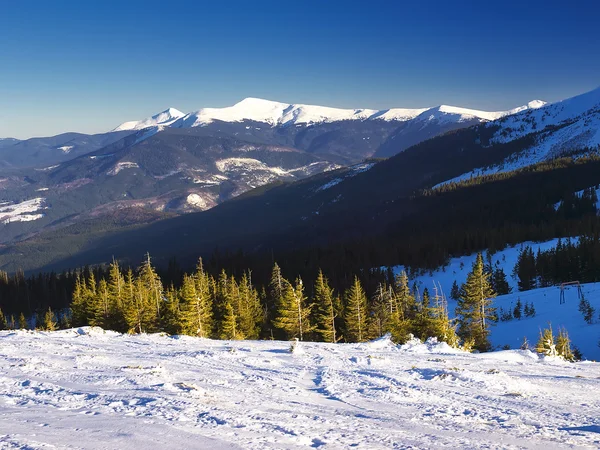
left=456, top=253, right=496, bottom=351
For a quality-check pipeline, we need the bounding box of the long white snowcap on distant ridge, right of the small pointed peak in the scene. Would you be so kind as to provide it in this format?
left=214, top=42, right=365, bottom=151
left=173, top=98, right=543, bottom=128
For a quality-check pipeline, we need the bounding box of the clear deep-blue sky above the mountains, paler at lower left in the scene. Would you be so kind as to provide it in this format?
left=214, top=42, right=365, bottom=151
left=0, top=0, right=600, bottom=138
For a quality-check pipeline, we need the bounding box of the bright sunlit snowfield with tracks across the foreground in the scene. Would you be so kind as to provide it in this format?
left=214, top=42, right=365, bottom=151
left=0, top=327, right=600, bottom=450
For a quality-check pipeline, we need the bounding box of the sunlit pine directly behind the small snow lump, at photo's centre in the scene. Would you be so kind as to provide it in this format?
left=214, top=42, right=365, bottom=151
left=273, top=278, right=314, bottom=340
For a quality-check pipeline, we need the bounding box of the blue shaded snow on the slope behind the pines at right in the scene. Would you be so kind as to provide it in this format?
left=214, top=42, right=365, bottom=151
left=394, top=238, right=600, bottom=361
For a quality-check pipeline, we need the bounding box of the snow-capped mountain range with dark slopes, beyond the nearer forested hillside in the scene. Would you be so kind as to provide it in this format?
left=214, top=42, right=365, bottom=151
left=0, top=86, right=600, bottom=269
